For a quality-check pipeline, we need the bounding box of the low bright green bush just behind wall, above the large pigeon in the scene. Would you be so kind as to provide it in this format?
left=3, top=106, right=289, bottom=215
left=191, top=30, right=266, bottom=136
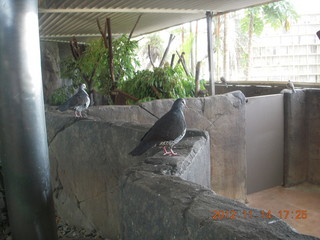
left=120, top=65, right=204, bottom=102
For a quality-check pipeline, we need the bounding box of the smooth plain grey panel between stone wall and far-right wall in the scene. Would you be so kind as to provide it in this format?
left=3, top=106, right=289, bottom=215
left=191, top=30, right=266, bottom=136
left=246, top=94, right=284, bottom=194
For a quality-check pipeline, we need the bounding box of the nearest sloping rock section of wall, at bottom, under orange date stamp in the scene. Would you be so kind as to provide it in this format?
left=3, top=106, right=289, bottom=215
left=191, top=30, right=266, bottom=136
left=120, top=166, right=317, bottom=240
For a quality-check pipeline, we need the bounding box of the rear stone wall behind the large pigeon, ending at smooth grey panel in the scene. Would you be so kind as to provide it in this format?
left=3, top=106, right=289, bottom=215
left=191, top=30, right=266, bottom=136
left=88, top=91, right=246, bottom=202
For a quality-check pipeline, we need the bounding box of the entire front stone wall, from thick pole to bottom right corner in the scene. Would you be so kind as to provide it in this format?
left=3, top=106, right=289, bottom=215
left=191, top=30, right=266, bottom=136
left=46, top=109, right=317, bottom=240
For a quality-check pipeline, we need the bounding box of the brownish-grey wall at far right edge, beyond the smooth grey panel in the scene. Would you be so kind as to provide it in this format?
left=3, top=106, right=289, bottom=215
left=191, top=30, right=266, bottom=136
left=284, top=89, right=320, bottom=186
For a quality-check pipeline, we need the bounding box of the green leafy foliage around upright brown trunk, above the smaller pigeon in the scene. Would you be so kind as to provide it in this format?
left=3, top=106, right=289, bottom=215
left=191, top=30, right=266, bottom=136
left=61, top=35, right=139, bottom=99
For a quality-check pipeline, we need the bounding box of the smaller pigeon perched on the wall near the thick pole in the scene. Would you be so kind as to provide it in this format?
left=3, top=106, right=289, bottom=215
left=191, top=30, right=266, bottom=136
left=57, top=84, right=90, bottom=118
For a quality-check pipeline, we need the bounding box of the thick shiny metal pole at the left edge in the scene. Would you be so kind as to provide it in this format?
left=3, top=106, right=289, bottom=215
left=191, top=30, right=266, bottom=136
left=0, top=0, right=57, bottom=240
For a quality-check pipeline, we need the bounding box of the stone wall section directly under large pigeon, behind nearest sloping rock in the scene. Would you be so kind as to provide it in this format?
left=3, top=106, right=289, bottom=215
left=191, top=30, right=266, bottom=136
left=46, top=112, right=210, bottom=239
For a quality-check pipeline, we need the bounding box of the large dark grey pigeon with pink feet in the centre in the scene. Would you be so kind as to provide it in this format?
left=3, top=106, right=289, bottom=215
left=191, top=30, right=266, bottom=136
left=129, top=98, right=187, bottom=156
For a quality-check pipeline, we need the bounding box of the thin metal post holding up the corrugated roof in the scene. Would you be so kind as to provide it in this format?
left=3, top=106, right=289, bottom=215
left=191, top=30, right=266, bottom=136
left=206, top=11, right=215, bottom=95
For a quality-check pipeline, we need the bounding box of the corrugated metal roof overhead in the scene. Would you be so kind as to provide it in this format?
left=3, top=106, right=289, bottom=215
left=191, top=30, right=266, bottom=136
left=39, top=0, right=278, bottom=41
